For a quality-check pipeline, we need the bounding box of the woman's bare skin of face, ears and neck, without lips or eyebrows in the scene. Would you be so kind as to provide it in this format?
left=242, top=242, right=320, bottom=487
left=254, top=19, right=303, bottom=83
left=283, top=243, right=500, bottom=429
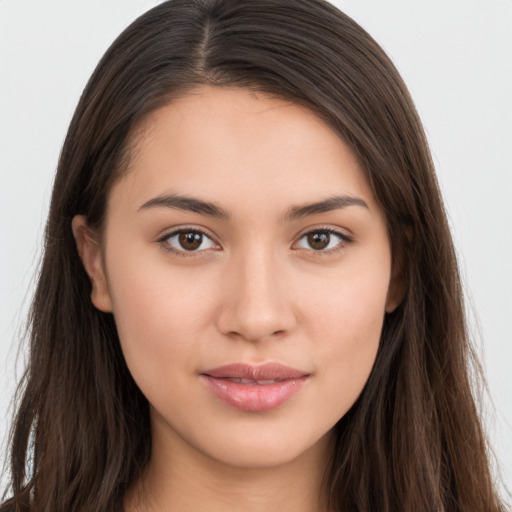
left=73, top=87, right=400, bottom=512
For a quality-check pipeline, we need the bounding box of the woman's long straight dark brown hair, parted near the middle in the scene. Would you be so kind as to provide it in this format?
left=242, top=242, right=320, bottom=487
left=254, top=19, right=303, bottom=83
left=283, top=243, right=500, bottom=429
left=0, top=0, right=503, bottom=512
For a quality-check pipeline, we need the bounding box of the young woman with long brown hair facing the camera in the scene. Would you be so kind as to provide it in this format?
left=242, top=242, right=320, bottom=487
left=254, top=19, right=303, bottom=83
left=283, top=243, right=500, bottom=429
left=2, top=0, right=502, bottom=511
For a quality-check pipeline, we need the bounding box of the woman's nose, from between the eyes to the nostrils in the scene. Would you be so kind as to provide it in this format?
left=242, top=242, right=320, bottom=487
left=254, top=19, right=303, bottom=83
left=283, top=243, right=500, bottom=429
left=217, top=246, right=296, bottom=342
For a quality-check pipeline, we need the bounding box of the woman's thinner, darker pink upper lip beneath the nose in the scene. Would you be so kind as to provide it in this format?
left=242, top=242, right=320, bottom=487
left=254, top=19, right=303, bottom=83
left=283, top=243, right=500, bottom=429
left=201, top=363, right=309, bottom=380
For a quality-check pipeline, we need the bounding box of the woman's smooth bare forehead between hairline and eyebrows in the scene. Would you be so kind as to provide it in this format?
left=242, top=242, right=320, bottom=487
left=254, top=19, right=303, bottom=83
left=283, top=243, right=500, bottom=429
left=113, top=87, right=373, bottom=216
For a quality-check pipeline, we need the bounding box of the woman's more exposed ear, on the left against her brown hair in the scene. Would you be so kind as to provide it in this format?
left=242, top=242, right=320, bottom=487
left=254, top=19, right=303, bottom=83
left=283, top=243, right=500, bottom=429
left=71, top=215, right=112, bottom=313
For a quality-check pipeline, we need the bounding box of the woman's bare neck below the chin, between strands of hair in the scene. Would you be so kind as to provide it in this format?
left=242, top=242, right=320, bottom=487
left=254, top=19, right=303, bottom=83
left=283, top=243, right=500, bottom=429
left=125, top=416, right=332, bottom=512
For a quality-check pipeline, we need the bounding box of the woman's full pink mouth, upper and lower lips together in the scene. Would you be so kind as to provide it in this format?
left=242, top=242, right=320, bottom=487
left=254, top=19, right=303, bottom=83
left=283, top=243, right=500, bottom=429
left=201, top=363, right=309, bottom=412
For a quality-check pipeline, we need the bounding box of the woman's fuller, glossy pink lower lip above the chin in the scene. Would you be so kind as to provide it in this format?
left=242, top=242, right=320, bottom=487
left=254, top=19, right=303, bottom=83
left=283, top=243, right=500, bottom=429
left=201, top=375, right=307, bottom=412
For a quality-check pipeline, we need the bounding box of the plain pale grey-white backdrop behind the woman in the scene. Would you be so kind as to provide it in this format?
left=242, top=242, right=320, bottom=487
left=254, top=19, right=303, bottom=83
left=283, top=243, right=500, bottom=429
left=0, top=0, right=512, bottom=496
